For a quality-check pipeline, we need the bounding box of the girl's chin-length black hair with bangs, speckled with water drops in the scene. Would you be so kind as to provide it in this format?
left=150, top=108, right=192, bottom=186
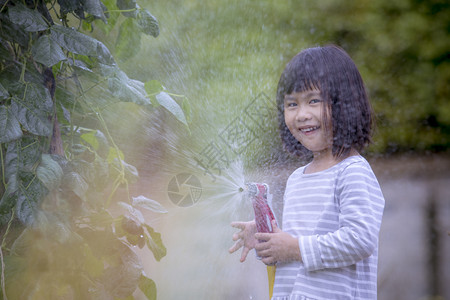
left=277, top=45, right=373, bottom=158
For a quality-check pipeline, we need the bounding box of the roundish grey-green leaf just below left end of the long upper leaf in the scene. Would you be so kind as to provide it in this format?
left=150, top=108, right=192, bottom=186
left=31, top=34, right=67, bottom=67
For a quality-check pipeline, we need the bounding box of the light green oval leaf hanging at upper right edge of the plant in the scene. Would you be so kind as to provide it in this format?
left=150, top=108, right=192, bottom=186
left=116, top=18, right=141, bottom=61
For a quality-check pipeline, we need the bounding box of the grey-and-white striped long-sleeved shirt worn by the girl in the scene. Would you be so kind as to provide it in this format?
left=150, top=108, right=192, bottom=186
left=272, top=156, right=384, bottom=300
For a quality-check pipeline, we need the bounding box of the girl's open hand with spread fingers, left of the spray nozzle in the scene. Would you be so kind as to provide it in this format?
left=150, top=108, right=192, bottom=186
left=228, top=221, right=258, bottom=262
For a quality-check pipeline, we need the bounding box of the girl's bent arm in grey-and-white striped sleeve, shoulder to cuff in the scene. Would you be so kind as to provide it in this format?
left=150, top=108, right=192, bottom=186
left=299, top=164, right=384, bottom=271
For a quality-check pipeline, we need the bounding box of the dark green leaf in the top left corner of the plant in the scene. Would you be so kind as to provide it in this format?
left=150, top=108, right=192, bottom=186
left=8, top=2, right=48, bottom=32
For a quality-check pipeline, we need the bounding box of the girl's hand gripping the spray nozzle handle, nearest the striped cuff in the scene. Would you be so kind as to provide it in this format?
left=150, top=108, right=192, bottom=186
left=255, top=221, right=302, bottom=265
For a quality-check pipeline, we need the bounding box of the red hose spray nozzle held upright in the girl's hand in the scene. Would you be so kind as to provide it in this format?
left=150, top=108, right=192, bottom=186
left=239, top=182, right=275, bottom=232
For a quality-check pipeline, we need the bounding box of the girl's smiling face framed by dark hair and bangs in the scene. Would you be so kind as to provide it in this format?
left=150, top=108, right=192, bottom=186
left=284, top=89, right=333, bottom=156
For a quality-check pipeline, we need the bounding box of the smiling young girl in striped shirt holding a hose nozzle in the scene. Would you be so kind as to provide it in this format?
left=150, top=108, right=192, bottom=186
left=230, top=46, right=384, bottom=300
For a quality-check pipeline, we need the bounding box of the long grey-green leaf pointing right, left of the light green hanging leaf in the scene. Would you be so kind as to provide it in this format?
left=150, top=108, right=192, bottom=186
left=51, top=25, right=114, bottom=64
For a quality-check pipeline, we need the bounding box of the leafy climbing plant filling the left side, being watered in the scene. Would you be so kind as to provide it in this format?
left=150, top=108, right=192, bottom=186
left=0, top=0, right=189, bottom=299
